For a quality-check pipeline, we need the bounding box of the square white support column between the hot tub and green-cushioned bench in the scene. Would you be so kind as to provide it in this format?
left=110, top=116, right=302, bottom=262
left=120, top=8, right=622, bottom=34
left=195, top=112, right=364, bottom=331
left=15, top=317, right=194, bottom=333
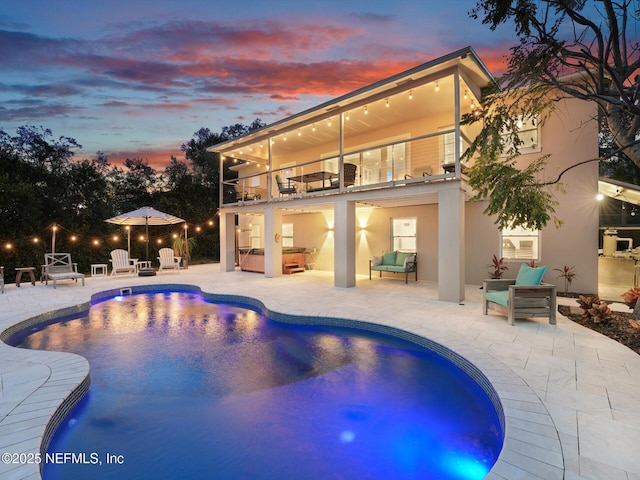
left=333, top=200, right=356, bottom=287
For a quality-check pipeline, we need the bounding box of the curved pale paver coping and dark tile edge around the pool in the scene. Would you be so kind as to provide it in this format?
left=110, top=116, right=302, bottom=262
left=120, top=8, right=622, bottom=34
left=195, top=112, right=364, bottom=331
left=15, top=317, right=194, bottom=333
left=0, top=283, right=565, bottom=480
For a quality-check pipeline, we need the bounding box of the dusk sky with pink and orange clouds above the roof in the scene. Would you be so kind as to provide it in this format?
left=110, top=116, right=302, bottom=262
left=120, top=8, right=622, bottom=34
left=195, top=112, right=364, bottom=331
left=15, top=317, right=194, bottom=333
left=0, top=0, right=516, bottom=169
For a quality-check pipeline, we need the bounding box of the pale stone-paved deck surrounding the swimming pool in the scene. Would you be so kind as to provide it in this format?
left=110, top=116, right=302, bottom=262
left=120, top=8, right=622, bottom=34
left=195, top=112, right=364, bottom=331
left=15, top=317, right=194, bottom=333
left=0, top=264, right=640, bottom=480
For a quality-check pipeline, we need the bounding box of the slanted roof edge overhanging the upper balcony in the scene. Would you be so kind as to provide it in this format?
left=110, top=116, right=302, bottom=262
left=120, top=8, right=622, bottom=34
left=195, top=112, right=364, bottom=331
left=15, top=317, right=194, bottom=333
left=207, top=47, right=494, bottom=153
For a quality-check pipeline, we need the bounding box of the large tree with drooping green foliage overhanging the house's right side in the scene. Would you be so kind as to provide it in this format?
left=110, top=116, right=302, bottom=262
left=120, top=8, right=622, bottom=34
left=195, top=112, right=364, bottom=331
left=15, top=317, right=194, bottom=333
left=463, top=0, right=640, bottom=229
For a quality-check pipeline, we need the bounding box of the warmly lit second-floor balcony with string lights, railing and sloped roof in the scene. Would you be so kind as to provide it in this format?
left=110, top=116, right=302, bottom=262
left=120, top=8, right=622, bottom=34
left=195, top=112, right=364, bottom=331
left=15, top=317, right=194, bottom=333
left=210, top=48, right=490, bottom=207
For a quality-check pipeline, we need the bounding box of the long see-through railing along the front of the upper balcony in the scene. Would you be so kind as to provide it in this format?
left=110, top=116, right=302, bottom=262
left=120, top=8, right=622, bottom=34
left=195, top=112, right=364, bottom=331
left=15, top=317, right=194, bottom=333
left=222, top=129, right=469, bottom=205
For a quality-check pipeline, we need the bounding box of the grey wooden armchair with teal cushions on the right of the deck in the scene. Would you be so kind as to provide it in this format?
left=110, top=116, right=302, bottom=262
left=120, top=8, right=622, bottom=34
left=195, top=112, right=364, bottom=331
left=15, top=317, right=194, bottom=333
left=482, top=263, right=556, bottom=325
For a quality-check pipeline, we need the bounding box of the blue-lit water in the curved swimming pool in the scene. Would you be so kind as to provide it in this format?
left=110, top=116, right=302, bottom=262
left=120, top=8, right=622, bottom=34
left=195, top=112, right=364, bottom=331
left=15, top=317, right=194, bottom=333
left=12, top=292, right=502, bottom=480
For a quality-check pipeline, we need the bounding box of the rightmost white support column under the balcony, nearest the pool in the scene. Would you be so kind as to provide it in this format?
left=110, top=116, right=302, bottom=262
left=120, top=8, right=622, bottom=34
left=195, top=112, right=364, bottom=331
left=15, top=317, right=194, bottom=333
left=438, top=187, right=465, bottom=302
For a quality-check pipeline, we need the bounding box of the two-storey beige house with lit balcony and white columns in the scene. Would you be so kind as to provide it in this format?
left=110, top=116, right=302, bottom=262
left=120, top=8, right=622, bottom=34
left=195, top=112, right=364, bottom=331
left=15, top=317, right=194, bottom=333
left=209, top=47, right=598, bottom=302
